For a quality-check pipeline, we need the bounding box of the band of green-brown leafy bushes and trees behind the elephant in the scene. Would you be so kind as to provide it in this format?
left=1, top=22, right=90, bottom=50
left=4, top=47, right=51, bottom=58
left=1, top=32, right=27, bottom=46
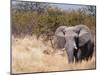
left=12, top=2, right=96, bottom=38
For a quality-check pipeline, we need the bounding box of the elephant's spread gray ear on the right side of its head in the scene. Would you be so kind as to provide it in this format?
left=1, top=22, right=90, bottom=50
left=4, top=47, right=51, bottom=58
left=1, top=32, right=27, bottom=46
left=74, top=25, right=91, bottom=47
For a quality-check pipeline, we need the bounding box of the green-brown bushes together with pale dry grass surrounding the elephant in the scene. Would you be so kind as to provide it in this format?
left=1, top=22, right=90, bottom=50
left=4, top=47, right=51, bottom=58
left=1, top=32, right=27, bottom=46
left=11, top=1, right=96, bottom=73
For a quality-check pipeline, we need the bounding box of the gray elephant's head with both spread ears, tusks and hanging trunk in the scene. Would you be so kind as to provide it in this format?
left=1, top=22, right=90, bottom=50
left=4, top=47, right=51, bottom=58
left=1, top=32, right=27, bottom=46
left=55, top=25, right=91, bottom=62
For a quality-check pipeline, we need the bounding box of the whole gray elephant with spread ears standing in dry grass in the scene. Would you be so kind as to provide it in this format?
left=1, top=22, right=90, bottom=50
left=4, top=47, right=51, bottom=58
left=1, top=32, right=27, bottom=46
left=55, top=25, right=94, bottom=63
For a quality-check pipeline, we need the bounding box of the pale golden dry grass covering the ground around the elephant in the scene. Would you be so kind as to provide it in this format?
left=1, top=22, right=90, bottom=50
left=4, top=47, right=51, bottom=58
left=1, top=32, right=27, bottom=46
left=12, top=36, right=96, bottom=73
